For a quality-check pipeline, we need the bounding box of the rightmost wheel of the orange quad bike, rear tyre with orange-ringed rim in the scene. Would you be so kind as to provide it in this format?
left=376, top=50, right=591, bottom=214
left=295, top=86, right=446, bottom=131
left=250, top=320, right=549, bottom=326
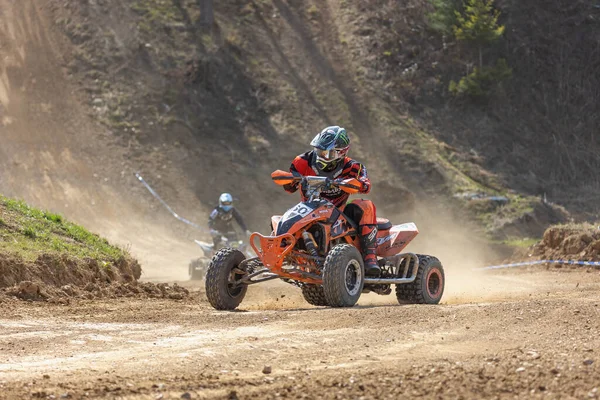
left=396, top=254, right=446, bottom=304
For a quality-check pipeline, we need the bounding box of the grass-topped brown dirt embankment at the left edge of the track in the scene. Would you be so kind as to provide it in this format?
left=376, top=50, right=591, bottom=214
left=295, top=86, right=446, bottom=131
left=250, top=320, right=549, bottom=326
left=0, top=196, right=188, bottom=301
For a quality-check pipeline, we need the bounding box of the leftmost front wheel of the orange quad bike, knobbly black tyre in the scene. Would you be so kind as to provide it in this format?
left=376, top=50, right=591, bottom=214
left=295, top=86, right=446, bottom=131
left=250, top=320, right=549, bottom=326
left=206, top=247, right=248, bottom=310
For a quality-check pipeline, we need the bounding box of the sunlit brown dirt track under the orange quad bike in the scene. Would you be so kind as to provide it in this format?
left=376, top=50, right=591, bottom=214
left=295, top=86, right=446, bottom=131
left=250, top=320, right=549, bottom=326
left=0, top=270, right=600, bottom=399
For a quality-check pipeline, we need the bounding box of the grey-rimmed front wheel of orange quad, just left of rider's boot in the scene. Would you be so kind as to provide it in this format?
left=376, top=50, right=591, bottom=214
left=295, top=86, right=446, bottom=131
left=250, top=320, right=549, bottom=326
left=323, top=244, right=365, bottom=307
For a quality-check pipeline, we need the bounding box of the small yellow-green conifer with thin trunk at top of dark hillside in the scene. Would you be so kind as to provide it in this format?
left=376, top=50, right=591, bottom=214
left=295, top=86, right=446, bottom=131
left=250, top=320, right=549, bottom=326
left=453, top=0, right=504, bottom=70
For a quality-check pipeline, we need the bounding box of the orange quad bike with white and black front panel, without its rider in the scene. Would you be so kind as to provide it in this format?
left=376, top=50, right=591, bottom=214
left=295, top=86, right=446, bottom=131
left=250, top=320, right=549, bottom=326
left=206, top=170, right=445, bottom=310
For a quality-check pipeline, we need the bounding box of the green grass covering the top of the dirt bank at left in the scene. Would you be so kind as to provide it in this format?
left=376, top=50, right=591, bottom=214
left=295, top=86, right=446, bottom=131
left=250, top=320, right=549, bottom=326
left=0, top=196, right=127, bottom=262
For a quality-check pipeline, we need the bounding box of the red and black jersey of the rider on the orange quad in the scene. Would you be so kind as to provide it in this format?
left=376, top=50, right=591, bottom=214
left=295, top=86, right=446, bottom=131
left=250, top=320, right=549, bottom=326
left=284, top=151, right=371, bottom=207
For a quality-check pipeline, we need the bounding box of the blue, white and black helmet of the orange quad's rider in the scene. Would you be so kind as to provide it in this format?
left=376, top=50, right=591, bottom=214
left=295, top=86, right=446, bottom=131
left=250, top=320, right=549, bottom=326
left=310, top=126, right=350, bottom=171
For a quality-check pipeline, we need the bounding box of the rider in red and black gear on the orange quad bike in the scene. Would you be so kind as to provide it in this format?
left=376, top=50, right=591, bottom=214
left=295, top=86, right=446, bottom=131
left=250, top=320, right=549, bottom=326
left=283, top=126, right=381, bottom=276
